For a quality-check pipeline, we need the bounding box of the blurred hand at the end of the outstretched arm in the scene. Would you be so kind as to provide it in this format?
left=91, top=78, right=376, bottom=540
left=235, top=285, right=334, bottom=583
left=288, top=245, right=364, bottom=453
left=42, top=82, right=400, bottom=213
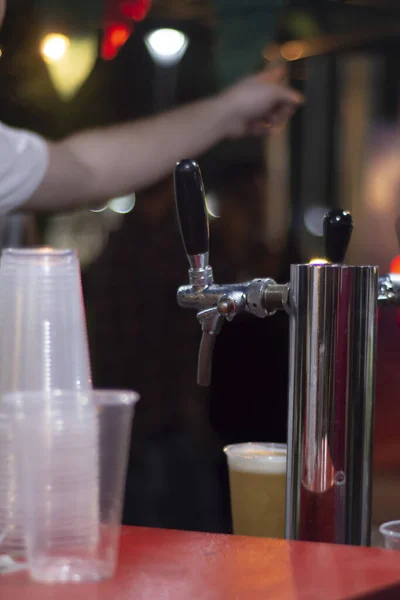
left=218, top=66, right=304, bottom=137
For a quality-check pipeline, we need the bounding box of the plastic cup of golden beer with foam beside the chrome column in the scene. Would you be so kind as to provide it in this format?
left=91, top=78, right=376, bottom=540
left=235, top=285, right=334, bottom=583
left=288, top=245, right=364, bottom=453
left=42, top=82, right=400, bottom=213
left=224, top=442, right=287, bottom=538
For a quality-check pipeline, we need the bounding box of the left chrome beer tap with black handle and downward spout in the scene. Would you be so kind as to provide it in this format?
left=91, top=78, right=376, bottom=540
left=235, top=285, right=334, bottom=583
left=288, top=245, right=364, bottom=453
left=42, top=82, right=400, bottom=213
left=174, top=160, right=288, bottom=386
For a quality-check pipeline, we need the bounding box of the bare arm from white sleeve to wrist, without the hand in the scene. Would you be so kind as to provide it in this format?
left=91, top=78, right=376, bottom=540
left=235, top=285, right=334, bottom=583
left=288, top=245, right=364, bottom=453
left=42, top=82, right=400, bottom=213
left=28, top=98, right=226, bottom=210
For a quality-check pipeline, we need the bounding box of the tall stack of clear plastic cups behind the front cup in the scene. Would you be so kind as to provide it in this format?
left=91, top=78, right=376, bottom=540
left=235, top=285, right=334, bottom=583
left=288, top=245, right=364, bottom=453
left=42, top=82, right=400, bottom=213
left=0, top=248, right=92, bottom=553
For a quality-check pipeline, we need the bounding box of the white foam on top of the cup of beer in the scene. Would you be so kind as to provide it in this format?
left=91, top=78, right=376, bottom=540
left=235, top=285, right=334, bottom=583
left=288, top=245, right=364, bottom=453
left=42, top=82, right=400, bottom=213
left=224, top=442, right=287, bottom=475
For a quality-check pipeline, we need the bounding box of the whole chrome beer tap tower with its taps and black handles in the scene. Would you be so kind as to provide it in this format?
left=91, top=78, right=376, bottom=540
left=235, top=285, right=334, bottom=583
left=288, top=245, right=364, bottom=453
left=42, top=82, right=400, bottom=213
left=174, top=160, right=400, bottom=546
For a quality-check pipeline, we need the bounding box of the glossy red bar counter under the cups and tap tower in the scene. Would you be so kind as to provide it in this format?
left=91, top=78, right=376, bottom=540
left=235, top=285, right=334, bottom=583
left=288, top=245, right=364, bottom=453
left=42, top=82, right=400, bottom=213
left=0, top=527, right=400, bottom=600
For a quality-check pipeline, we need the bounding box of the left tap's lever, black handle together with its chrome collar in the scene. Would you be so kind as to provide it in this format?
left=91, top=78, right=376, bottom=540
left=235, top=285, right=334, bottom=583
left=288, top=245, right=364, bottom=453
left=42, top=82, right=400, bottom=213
left=174, top=159, right=212, bottom=287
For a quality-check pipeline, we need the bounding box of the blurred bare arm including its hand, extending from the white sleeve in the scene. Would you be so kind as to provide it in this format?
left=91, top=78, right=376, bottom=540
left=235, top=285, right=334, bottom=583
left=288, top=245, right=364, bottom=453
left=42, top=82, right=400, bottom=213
left=25, top=74, right=301, bottom=210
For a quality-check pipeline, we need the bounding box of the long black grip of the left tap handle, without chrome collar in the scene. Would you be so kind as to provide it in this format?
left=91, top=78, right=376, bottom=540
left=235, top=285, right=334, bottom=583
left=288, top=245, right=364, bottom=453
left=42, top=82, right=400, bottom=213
left=174, top=159, right=209, bottom=256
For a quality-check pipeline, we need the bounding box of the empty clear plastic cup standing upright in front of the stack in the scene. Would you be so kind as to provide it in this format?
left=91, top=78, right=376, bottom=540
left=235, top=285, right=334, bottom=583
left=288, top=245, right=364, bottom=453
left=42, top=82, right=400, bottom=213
left=4, top=390, right=139, bottom=583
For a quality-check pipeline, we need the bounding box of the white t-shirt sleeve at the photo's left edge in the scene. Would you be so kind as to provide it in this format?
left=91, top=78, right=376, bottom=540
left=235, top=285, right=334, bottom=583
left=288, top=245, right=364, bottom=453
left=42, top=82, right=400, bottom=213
left=0, top=122, right=49, bottom=214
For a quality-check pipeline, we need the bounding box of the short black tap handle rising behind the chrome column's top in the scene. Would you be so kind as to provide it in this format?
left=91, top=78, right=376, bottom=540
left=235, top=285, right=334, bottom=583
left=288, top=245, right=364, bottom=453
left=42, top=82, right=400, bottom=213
left=324, top=209, right=353, bottom=263
